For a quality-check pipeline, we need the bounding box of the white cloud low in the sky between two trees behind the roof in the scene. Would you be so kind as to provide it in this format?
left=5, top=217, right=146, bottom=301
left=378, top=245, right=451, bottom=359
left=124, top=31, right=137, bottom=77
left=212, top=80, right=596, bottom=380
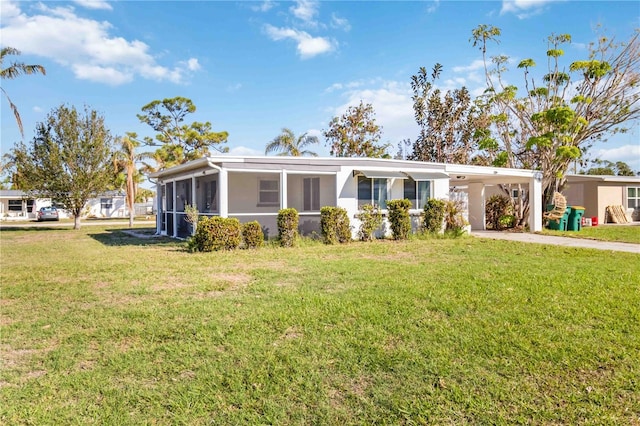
left=331, top=80, right=419, bottom=145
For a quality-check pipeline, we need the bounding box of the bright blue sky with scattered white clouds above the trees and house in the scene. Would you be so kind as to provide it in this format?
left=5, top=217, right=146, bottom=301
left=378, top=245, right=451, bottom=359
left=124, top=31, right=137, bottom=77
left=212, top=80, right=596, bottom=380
left=0, top=0, right=640, bottom=170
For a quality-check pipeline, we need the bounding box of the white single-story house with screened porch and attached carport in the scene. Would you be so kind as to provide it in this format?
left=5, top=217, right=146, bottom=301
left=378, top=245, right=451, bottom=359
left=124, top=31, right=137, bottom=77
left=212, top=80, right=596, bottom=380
left=151, top=155, right=543, bottom=238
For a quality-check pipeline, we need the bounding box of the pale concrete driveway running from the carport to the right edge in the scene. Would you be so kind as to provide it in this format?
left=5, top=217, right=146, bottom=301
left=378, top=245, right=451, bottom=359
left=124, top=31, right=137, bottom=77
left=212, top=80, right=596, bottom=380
left=471, top=231, right=640, bottom=254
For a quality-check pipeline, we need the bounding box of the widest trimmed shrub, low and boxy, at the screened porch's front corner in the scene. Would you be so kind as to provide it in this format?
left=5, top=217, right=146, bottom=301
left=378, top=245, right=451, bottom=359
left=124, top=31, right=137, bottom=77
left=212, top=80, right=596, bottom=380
left=188, top=216, right=242, bottom=252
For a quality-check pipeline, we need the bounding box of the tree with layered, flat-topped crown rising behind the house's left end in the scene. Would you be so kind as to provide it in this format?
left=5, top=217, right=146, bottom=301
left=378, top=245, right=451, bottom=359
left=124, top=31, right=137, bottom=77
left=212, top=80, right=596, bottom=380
left=137, top=96, right=229, bottom=170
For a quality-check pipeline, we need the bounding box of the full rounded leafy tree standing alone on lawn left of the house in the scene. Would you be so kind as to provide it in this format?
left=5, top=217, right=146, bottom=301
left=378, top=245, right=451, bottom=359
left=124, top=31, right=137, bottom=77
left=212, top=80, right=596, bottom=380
left=11, top=105, right=114, bottom=229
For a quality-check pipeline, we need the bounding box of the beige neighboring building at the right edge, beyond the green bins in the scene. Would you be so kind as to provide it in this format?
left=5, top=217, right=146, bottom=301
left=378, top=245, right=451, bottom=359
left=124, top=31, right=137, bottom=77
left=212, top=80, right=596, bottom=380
left=562, top=175, right=640, bottom=223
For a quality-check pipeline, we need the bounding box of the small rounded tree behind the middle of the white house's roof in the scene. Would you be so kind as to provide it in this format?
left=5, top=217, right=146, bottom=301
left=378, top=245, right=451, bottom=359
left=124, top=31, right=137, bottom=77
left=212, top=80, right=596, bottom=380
left=323, top=101, right=389, bottom=158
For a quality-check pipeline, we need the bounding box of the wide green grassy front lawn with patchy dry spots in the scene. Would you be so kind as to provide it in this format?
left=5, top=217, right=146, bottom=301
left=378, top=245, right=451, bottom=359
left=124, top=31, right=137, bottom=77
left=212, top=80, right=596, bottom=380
left=0, top=227, right=640, bottom=425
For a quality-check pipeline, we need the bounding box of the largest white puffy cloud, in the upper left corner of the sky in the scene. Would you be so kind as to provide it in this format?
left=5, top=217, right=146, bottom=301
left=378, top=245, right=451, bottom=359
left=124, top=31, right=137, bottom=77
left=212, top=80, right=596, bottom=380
left=2, top=2, right=200, bottom=86
